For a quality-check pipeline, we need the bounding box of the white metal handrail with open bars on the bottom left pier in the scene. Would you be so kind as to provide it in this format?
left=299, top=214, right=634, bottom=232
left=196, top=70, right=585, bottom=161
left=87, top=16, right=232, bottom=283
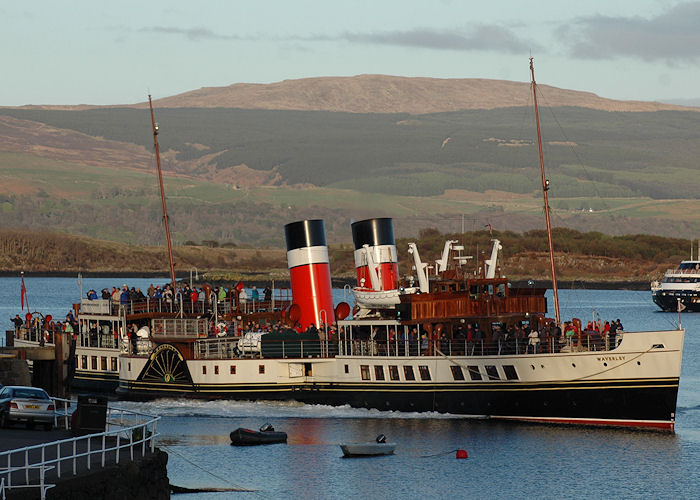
left=0, top=404, right=160, bottom=498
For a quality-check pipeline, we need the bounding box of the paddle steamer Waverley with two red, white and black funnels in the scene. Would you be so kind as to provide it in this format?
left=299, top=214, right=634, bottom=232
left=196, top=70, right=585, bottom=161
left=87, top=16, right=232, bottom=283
left=6, top=62, right=685, bottom=431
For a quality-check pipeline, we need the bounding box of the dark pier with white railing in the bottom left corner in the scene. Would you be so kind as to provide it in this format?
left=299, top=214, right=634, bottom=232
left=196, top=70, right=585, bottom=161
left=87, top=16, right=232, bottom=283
left=0, top=398, right=170, bottom=500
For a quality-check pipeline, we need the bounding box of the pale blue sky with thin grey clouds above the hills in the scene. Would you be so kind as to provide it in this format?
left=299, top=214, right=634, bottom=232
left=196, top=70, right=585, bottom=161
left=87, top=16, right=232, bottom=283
left=0, top=0, right=700, bottom=106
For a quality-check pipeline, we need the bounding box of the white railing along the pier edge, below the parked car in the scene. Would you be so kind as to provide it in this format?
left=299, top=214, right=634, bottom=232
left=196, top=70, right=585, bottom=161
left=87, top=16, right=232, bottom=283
left=0, top=398, right=160, bottom=499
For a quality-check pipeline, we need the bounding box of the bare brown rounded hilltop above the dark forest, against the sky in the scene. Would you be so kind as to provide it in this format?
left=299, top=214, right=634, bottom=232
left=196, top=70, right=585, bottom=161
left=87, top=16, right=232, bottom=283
left=13, top=75, right=700, bottom=115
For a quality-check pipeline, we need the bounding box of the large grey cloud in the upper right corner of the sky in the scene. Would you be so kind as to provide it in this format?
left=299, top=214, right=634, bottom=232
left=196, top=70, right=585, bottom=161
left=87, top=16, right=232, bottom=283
left=557, top=2, right=700, bottom=64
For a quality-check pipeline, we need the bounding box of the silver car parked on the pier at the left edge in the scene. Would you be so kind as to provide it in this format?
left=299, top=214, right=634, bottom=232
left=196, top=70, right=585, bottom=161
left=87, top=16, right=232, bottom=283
left=0, top=385, right=56, bottom=431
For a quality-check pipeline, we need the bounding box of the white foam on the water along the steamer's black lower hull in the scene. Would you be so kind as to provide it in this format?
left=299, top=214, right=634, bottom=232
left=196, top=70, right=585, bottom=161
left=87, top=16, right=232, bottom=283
left=112, top=399, right=464, bottom=419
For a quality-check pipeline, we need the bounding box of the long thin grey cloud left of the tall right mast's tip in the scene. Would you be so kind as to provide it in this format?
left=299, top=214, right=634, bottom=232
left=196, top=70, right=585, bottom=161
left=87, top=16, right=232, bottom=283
left=333, top=25, right=540, bottom=54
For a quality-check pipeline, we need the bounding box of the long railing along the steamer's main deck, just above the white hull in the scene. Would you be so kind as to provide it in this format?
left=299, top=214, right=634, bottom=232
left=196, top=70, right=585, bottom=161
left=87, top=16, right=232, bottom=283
left=189, top=334, right=622, bottom=359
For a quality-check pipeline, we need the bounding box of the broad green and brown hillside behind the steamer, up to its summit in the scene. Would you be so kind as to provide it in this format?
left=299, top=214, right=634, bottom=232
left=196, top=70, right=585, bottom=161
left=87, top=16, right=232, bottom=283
left=0, top=75, right=700, bottom=248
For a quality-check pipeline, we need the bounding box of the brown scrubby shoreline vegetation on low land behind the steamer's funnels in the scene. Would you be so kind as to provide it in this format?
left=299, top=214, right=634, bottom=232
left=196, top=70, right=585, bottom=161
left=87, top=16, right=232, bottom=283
left=0, top=228, right=690, bottom=290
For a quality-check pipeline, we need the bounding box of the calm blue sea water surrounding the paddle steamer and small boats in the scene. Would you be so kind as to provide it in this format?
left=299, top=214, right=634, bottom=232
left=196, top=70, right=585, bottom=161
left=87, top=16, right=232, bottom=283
left=0, top=277, right=700, bottom=499
